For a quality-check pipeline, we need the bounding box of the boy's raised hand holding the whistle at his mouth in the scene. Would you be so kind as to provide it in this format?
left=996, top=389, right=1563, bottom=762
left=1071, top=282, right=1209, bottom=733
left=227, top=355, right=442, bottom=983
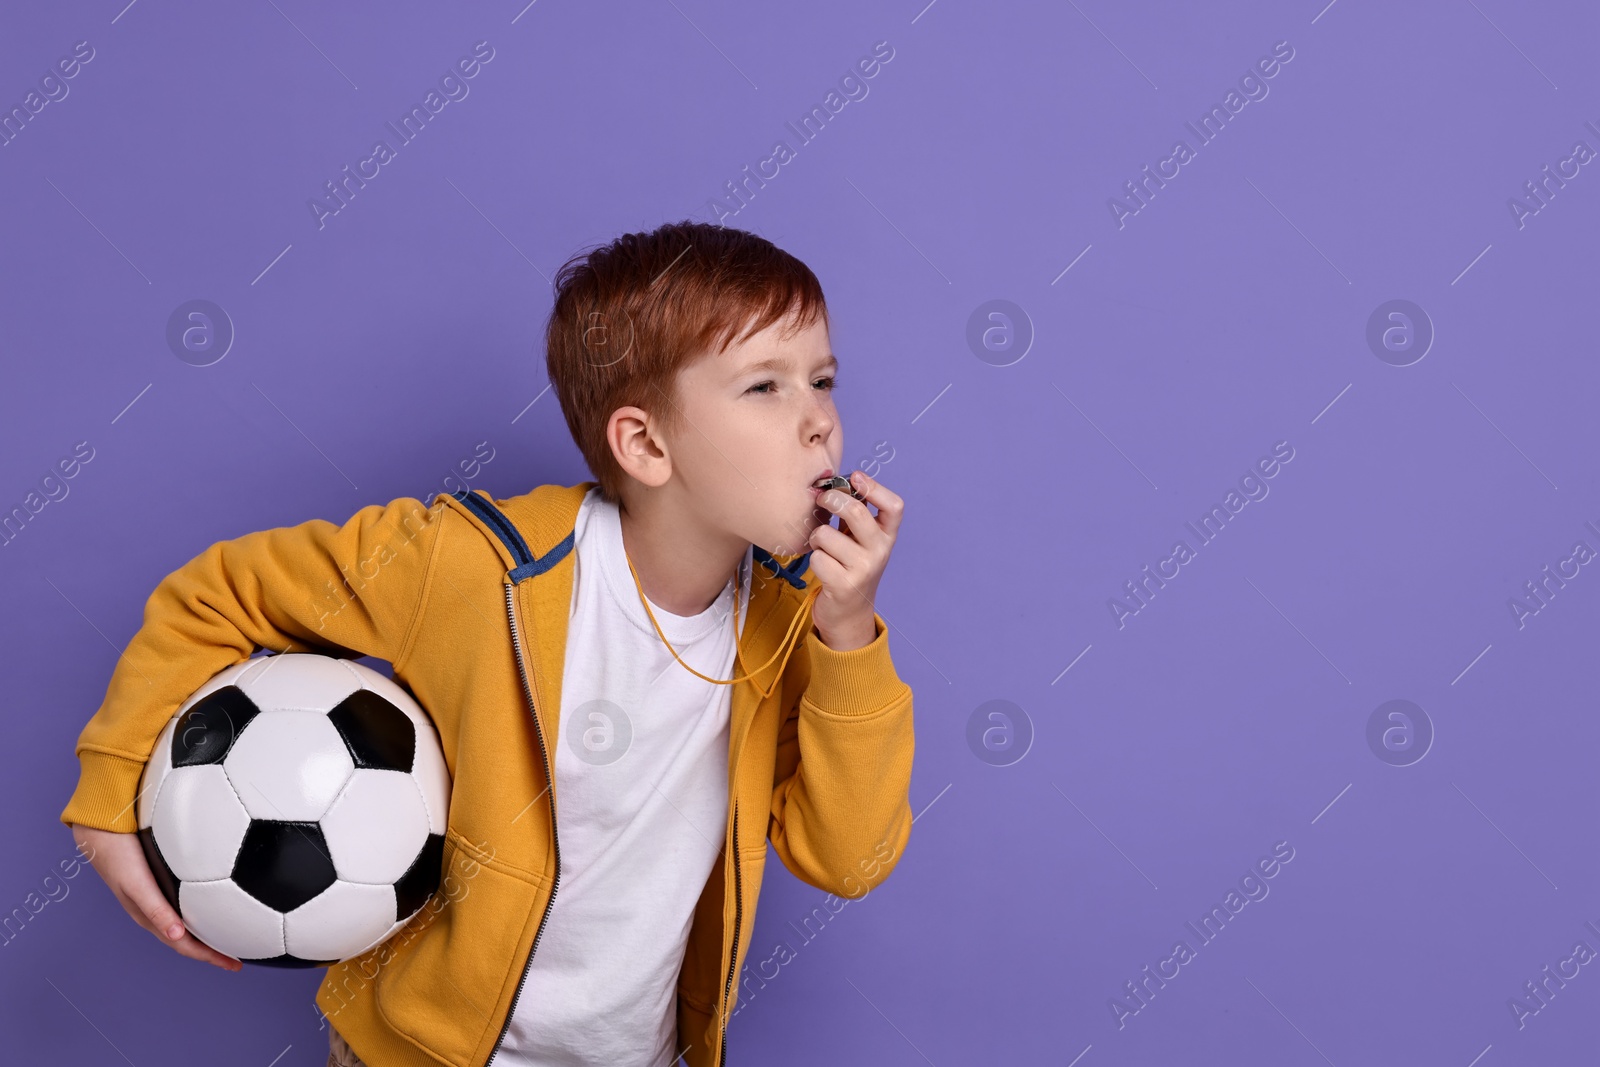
left=810, top=470, right=906, bottom=651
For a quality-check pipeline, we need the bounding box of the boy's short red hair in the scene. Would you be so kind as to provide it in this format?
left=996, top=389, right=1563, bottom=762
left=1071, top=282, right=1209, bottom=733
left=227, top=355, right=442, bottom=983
left=544, top=219, right=827, bottom=502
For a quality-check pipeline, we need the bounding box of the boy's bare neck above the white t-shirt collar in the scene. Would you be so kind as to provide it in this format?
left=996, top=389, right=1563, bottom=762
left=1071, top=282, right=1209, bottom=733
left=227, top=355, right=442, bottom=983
left=618, top=493, right=749, bottom=616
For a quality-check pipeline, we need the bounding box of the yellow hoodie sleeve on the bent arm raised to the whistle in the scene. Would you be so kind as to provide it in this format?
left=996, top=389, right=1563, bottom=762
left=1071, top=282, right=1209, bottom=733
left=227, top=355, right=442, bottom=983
left=768, top=613, right=915, bottom=897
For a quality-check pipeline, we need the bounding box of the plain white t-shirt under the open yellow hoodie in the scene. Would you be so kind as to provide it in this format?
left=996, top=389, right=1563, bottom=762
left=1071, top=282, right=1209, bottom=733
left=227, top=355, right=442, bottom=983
left=494, top=488, right=750, bottom=1067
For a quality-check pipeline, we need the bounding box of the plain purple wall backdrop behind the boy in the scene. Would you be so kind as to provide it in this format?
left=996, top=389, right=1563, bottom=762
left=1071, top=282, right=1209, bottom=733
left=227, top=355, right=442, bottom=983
left=0, top=0, right=1600, bottom=1067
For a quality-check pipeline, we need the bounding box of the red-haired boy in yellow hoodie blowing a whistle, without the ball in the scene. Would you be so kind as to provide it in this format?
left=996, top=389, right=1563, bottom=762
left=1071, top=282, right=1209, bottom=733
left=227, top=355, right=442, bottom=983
left=61, top=221, right=914, bottom=1067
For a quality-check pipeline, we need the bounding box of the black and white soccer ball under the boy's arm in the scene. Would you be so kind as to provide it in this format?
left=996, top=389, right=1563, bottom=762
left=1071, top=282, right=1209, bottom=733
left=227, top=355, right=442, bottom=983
left=138, top=653, right=450, bottom=966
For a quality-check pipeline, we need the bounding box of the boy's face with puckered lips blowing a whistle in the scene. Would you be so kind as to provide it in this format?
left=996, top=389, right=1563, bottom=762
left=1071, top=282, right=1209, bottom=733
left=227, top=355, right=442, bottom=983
left=669, top=315, right=845, bottom=555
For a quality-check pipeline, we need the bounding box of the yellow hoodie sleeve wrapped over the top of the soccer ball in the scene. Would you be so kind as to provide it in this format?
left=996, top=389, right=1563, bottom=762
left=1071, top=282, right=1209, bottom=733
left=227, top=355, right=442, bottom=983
left=61, top=498, right=445, bottom=833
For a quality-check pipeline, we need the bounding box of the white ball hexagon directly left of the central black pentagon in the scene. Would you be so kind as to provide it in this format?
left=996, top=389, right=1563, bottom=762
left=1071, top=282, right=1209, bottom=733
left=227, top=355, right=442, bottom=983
left=150, top=763, right=250, bottom=881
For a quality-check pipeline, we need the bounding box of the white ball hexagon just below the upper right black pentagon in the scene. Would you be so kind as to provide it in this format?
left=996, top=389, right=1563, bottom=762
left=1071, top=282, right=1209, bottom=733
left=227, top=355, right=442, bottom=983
left=322, top=768, right=427, bottom=883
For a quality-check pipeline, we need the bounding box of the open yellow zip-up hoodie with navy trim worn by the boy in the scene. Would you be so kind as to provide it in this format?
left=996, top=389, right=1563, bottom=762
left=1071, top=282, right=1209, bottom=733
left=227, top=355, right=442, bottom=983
left=61, top=482, right=914, bottom=1067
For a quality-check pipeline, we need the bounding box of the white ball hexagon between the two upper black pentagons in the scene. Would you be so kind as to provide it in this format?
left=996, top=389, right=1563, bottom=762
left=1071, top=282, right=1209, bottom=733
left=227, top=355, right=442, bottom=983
left=222, top=713, right=355, bottom=822
